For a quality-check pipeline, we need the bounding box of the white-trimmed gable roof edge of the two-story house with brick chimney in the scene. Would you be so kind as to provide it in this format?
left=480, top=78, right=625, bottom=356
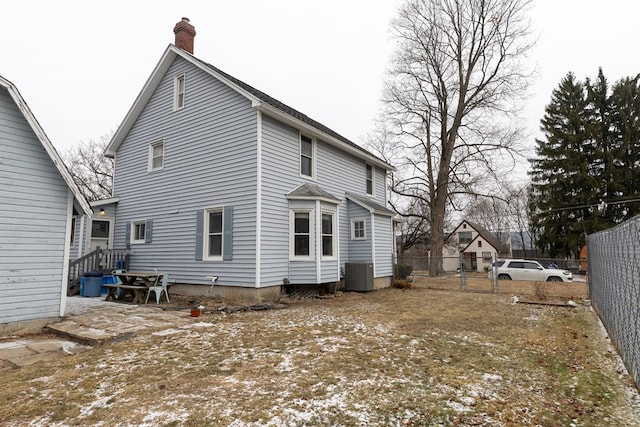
left=105, top=44, right=394, bottom=170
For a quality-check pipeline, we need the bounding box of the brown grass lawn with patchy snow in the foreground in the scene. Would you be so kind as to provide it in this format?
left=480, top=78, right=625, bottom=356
left=0, top=282, right=640, bottom=426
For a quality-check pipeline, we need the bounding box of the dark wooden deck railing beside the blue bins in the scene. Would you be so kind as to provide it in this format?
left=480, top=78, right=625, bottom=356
left=67, top=247, right=131, bottom=296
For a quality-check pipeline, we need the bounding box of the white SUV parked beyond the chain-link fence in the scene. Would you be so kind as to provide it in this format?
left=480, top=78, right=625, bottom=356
left=489, top=259, right=573, bottom=282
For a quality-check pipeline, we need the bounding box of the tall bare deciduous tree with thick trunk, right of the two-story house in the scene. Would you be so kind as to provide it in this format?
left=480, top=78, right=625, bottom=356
left=384, top=0, right=532, bottom=275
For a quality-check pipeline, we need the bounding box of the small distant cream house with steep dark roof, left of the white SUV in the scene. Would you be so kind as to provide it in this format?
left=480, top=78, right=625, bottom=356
left=443, top=220, right=509, bottom=271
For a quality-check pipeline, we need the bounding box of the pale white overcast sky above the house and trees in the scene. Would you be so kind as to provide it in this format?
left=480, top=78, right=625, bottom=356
left=0, top=0, right=640, bottom=177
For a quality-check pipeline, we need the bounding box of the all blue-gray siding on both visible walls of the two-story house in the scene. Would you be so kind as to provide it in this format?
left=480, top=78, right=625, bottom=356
left=114, top=57, right=392, bottom=287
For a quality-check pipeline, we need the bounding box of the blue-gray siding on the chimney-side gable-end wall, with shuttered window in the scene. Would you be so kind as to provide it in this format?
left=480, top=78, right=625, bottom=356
left=114, top=58, right=257, bottom=286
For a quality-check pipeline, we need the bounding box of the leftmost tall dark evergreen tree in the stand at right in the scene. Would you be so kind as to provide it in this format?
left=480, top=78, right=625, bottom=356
left=530, top=73, right=593, bottom=257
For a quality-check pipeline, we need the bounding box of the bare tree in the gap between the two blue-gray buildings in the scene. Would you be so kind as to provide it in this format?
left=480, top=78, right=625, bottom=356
left=62, top=133, right=113, bottom=202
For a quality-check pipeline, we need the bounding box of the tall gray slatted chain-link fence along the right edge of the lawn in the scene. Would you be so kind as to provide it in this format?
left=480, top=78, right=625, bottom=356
left=587, top=216, right=640, bottom=392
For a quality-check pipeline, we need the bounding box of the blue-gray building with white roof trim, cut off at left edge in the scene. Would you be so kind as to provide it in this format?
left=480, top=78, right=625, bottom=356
left=0, top=76, right=91, bottom=329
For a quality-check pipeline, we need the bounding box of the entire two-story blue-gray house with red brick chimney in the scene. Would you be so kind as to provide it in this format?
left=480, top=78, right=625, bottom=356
left=106, top=18, right=394, bottom=298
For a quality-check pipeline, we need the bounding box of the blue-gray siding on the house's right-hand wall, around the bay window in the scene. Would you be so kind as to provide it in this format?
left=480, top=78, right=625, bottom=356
left=261, top=115, right=392, bottom=286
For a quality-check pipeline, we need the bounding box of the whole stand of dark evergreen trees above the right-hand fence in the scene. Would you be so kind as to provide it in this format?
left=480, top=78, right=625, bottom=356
left=529, top=69, right=640, bottom=256
